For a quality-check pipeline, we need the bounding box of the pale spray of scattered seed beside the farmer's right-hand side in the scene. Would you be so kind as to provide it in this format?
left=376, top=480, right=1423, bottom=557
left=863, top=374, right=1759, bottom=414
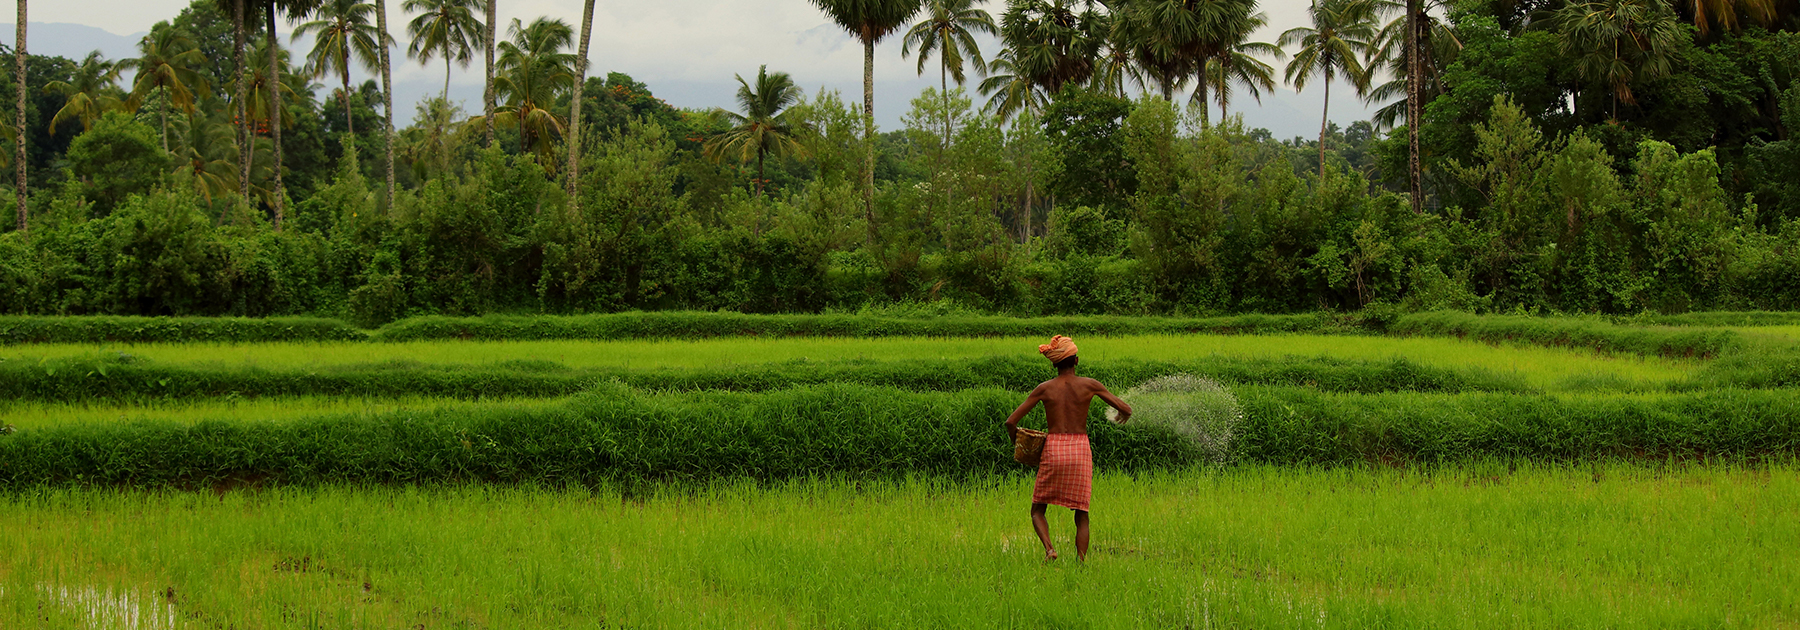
left=1107, top=374, right=1244, bottom=464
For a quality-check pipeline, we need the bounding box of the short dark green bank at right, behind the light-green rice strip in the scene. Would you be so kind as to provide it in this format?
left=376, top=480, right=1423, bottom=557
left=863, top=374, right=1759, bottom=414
left=1388, top=311, right=1739, bottom=358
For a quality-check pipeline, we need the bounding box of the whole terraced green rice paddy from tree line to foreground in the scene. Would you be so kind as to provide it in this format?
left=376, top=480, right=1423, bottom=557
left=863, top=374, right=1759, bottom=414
left=0, top=313, right=1800, bottom=628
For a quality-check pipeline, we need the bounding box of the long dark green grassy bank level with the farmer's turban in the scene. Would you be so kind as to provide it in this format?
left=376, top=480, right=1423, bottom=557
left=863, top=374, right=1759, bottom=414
left=0, top=353, right=1530, bottom=406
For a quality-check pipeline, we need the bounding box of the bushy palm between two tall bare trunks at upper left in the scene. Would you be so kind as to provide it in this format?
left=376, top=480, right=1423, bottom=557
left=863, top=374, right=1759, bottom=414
left=493, top=18, right=576, bottom=171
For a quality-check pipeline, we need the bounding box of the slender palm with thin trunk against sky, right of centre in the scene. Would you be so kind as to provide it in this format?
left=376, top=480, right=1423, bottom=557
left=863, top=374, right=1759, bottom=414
left=1282, top=0, right=1377, bottom=178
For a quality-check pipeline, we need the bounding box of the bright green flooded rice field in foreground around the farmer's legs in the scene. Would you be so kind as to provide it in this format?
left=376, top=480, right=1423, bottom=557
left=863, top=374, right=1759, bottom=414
left=0, top=464, right=1800, bottom=628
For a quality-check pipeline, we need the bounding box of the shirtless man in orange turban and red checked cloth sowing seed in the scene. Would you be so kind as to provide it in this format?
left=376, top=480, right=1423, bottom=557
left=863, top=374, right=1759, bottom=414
left=1006, top=335, right=1130, bottom=560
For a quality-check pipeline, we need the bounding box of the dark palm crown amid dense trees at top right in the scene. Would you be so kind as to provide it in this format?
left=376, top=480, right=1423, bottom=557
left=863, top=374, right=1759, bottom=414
left=1557, top=0, right=1683, bottom=121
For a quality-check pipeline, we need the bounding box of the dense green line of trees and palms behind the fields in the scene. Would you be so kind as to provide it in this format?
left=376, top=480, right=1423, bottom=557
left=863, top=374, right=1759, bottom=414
left=0, top=0, right=1800, bottom=322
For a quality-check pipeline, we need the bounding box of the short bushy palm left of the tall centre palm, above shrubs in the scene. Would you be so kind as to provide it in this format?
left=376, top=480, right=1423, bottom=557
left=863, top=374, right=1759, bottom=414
left=706, top=65, right=808, bottom=196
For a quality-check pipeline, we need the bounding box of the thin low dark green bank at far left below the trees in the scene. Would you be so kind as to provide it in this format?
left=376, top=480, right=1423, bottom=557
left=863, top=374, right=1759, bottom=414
left=0, top=315, right=367, bottom=346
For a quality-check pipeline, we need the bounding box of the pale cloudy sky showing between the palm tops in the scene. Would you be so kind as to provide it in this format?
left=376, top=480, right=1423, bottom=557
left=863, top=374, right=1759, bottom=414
left=0, top=0, right=1373, bottom=139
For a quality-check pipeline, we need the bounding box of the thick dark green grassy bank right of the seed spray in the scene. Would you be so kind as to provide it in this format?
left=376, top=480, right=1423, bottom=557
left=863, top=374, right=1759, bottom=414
left=1237, top=387, right=1800, bottom=464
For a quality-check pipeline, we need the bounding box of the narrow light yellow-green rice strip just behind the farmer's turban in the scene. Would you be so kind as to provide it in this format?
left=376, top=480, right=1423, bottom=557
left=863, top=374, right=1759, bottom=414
left=0, top=335, right=1705, bottom=391
